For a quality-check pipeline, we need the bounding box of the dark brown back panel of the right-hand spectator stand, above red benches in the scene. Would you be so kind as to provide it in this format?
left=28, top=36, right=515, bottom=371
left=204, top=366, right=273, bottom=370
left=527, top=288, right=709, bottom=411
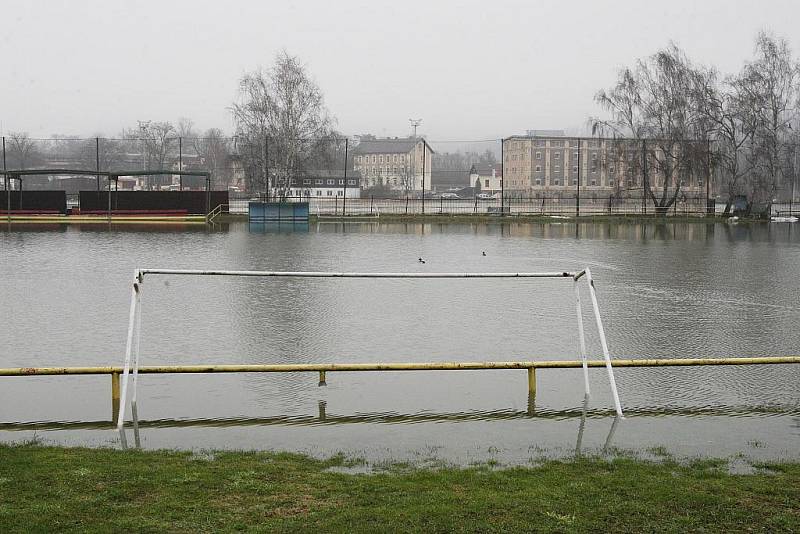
left=79, top=191, right=228, bottom=214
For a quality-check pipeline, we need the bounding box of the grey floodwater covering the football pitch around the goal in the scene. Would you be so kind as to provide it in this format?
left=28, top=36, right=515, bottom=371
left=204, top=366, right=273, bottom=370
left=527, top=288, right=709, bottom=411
left=0, top=221, right=800, bottom=464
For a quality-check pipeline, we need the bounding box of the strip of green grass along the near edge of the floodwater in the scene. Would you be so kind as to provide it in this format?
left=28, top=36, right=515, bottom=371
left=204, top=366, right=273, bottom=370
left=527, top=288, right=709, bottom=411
left=0, top=445, right=800, bottom=533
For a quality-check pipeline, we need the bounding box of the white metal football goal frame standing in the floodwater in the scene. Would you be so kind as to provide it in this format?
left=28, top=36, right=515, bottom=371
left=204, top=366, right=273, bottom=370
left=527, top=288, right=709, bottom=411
left=117, top=268, right=622, bottom=443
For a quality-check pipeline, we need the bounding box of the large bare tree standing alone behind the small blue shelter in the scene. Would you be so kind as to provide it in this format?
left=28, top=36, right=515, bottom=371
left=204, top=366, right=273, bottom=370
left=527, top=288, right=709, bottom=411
left=231, top=51, right=333, bottom=197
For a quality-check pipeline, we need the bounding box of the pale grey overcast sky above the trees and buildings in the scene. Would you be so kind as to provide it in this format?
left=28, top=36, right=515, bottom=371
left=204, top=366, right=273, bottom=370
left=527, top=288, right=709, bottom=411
left=0, top=0, right=800, bottom=140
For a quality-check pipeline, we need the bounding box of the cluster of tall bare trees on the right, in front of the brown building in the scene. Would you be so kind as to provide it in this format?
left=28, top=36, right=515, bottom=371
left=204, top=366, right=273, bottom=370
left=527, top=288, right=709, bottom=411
left=590, top=31, right=800, bottom=213
